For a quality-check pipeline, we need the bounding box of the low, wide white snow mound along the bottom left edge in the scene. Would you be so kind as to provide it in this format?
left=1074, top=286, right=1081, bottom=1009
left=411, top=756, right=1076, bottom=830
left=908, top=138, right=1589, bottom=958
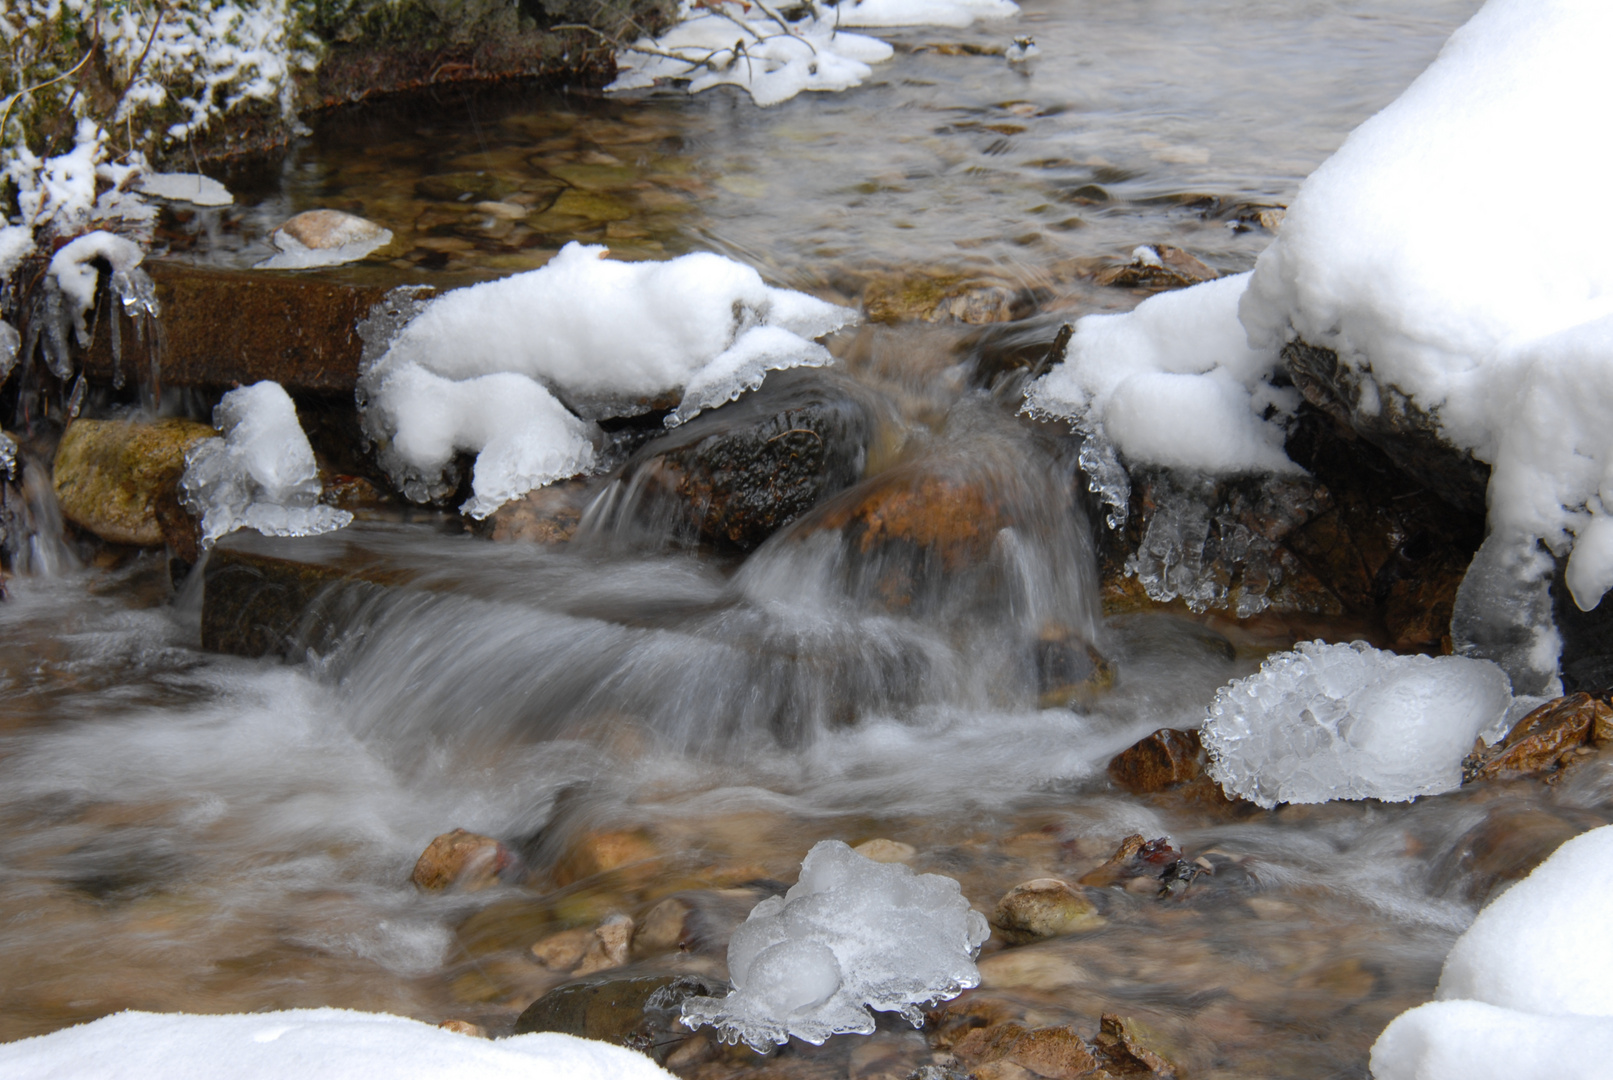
left=0, top=1009, right=671, bottom=1080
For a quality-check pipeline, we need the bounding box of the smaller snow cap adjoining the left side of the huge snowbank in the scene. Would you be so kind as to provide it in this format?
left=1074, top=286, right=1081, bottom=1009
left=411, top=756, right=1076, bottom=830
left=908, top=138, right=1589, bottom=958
left=1026, top=274, right=1298, bottom=474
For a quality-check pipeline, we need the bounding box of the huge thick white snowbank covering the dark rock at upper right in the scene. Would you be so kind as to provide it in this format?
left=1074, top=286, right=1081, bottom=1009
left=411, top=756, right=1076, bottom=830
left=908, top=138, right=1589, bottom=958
left=1242, top=0, right=1613, bottom=608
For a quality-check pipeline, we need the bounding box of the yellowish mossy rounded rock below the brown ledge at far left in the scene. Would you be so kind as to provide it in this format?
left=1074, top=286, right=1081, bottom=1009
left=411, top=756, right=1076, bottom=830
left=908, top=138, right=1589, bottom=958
left=53, top=419, right=218, bottom=561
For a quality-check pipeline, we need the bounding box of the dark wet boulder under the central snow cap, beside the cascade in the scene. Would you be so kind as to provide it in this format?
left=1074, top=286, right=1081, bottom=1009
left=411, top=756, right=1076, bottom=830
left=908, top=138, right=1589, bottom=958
left=613, top=369, right=884, bottom=551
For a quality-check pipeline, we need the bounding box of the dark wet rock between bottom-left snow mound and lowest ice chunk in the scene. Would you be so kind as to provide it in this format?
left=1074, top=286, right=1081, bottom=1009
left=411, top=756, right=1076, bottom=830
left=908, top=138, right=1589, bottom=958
left=515, top=975, right=729, bottom=1062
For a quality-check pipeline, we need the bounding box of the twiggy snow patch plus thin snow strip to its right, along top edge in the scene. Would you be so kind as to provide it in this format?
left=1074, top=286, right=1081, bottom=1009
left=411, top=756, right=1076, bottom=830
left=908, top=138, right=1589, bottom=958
left=606, top=0, right=1019, bottom=106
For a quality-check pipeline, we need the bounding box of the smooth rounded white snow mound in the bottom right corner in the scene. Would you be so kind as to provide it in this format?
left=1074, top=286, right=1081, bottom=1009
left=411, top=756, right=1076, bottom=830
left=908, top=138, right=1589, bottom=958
left=1371, top=825, right=1613, bottom=1080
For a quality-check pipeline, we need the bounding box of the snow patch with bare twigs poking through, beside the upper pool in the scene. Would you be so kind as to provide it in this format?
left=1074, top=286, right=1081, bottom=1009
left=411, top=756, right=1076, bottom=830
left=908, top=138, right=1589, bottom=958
left=605, top=0, right=894, bottom=106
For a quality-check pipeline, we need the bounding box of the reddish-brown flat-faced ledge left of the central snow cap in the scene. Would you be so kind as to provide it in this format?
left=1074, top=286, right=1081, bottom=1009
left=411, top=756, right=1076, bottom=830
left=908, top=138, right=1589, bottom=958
left=85, top=260, right=432, bottom=394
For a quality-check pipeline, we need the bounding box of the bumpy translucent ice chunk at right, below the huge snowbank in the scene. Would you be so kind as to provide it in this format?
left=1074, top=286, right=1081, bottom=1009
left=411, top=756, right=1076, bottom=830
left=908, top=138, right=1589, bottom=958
left=1202, top=642, right=1511, bottom=808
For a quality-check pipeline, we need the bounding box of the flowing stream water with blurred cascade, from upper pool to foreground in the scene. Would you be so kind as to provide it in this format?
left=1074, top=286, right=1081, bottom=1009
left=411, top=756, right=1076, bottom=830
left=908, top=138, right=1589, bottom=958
left=12, top=0, right=1613, bottom=1078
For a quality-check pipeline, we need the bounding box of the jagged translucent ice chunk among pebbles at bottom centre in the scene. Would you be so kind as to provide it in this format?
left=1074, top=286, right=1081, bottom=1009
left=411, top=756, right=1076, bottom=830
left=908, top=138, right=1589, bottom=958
left=684, top=840, right=990, bottom=1051
